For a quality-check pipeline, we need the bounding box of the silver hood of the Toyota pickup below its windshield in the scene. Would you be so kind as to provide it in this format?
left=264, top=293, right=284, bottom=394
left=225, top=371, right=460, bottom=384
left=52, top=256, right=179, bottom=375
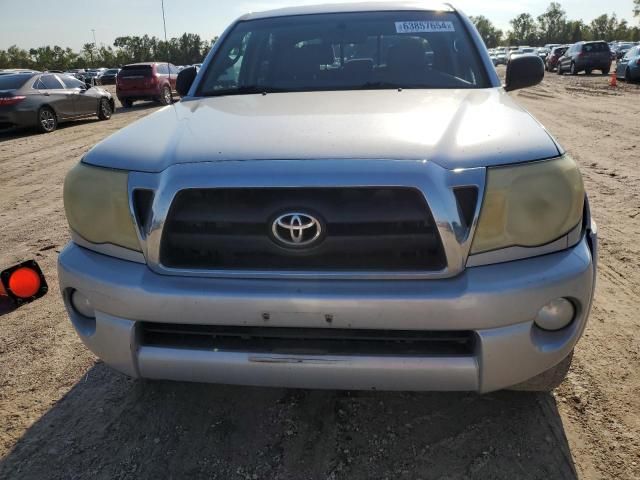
left=84, top=89, right=560, bottom=172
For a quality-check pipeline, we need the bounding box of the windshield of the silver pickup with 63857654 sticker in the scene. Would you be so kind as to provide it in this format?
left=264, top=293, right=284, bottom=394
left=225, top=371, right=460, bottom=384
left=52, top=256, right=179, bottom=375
left=198, top=12, right=489, bottom=96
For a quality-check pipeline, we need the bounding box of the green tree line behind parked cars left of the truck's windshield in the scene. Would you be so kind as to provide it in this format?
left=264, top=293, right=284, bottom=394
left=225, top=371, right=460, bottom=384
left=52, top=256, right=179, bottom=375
left=0, top=33, right=216, bottom=70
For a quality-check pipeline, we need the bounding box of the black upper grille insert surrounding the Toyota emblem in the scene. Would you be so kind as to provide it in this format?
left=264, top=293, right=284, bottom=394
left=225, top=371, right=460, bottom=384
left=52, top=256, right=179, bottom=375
left=160, top=188, right=446, bottom=271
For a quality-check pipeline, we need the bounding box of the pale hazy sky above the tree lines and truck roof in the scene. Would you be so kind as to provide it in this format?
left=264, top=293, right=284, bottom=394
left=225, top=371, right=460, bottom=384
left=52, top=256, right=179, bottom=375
left=0, top=0, right=638, bottom=50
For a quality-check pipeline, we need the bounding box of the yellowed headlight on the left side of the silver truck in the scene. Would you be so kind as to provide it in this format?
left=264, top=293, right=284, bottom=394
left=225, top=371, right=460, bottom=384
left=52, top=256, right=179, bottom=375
left=64, top=163, right=141, bottom=251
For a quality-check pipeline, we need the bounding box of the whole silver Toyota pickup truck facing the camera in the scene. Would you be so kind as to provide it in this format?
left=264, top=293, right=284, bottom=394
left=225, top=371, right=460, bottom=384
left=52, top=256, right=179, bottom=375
left=59, top=1, right=597, bottom=392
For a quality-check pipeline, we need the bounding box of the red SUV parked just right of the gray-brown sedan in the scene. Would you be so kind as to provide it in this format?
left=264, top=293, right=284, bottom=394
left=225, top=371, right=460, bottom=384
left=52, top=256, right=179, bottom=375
left=116, top=62, right=179, bottom=108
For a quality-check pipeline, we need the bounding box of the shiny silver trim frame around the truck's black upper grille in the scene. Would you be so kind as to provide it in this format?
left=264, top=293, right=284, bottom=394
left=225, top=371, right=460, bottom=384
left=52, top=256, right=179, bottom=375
left=129, top=159, right=486, bottom=280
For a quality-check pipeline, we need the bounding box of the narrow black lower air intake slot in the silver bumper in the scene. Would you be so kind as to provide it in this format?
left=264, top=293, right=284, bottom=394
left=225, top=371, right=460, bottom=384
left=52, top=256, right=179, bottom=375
left=140, top=322, right=475, bottom=356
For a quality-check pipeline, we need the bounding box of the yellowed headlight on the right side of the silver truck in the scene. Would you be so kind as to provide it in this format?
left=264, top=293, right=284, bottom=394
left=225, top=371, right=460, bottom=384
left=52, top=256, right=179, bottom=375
left=471, top=155, right=584, bottom=254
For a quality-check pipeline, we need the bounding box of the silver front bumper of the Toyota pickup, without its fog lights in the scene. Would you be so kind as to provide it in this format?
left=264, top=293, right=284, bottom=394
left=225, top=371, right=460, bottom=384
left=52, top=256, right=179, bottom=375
left=59, top=232, right=597, bottom=392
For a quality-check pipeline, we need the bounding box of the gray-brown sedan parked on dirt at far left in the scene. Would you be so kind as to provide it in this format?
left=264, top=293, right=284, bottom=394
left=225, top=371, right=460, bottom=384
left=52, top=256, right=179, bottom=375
left=0, top=73, right=115, bottom=133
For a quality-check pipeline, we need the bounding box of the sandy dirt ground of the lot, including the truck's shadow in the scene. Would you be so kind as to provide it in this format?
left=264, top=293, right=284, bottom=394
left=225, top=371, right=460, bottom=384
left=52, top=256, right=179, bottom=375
left=0, top=72, right=640, bottom=480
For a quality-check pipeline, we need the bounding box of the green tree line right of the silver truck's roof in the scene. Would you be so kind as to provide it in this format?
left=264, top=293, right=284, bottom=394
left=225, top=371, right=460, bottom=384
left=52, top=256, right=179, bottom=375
left=471, top=0, right=640, bottom=48
